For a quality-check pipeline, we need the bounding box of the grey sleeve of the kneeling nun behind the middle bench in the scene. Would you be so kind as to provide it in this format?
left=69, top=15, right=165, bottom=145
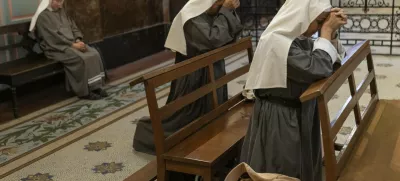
left=184, top=7, right=242, bottom=50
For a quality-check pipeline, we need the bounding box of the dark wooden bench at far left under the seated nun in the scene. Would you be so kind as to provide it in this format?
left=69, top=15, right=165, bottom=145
left=0, top=22, right=64, bottom=118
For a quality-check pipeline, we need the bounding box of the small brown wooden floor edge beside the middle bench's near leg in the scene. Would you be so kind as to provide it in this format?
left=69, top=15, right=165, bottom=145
left=124, top=160, right=157, bottom=181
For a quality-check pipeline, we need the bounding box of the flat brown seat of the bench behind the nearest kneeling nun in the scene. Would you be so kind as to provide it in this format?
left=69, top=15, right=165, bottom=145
left=163, top=102, right=253, bottom=167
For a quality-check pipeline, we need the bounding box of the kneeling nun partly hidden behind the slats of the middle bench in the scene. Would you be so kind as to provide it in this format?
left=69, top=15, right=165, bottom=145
left=133, top=0, right=242, bottom=154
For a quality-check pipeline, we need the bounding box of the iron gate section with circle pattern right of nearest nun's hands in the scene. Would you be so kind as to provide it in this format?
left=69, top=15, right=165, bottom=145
left=332, top=0, right=400, bottom=55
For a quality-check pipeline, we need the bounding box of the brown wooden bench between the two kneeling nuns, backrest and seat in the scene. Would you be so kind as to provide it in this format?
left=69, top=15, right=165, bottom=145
left=130, top=38, right=253, bottom=181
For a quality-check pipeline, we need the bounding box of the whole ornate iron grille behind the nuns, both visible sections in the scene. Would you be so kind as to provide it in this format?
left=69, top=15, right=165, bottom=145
left=237, top=0, right=400, bottom=55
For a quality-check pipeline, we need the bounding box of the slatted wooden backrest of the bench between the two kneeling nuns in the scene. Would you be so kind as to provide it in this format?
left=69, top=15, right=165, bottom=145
left=130, top=38, right=253, bottom=155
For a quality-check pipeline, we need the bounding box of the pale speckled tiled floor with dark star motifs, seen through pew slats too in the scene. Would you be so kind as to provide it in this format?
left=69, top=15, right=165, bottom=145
left=3, top=53, right=400, bottom=181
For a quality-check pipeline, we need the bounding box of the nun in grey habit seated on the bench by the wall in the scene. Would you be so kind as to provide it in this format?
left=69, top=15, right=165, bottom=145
left=29, top=0, right=108, bottom=100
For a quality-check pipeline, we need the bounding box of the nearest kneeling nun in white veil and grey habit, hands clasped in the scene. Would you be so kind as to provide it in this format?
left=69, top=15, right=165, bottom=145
left=241, top=0, right=347, bottom=181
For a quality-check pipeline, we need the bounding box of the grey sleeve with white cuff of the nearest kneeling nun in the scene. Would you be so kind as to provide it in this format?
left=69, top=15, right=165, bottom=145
left=287, top=39, right=337, bottom=84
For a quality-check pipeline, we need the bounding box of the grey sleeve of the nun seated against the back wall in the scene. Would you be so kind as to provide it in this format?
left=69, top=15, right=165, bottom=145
left=36, top=13, right=72, bottom=51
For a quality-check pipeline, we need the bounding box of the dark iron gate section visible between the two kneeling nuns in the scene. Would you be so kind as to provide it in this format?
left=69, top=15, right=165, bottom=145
left=236, top=0, right=284, bottom=46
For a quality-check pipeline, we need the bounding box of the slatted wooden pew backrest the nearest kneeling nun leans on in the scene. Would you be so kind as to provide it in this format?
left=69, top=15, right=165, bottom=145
left=300, top=41, right=379, bottom=181
